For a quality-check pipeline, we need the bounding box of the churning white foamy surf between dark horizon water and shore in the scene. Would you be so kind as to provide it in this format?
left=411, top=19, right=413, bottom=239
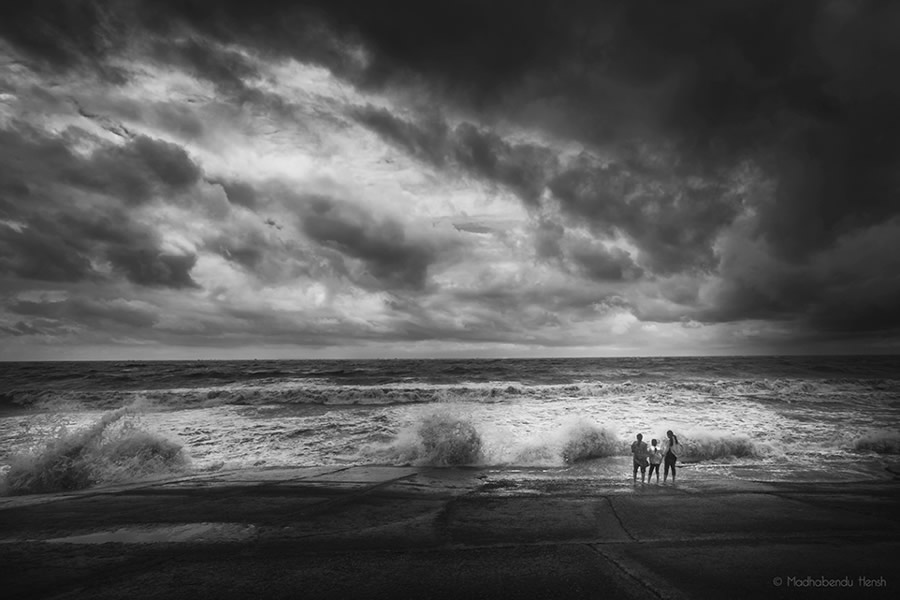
left=0, top=360, right=900, bottom=487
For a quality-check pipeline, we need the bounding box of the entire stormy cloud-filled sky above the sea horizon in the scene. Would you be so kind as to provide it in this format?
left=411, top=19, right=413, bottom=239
left=0, top=0, right=900, bottom=360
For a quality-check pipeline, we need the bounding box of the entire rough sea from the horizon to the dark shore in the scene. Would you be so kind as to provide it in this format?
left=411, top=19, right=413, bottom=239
left=0, top=356, right=900, bottom=494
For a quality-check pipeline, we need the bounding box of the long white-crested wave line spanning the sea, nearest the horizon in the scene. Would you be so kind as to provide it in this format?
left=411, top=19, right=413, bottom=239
left=0, top=379, right=900, bottom=412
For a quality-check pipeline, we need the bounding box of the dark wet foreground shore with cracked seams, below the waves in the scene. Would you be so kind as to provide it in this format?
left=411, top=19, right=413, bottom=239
left=0, top=467, right=900, bottom=599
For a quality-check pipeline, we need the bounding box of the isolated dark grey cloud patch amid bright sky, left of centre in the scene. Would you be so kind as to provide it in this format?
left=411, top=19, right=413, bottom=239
left=299, top=196, right=436, bottom=289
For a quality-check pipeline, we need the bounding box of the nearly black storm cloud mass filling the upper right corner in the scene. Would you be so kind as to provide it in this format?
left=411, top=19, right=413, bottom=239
left=324, top=1, right=900, bottom=252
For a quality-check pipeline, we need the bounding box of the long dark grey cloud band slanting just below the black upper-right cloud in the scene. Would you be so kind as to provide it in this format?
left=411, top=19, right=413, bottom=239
left=357, top=107, right=742, bottom=277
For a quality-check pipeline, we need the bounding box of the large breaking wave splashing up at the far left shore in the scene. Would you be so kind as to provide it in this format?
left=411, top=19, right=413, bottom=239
left=0, top=407, right=187, bottom=495
